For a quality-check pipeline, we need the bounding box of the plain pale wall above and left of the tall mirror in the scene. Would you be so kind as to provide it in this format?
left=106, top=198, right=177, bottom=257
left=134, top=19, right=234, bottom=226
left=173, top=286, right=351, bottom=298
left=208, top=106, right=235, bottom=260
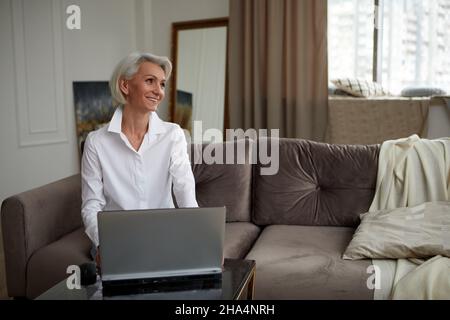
left=151, top=0, right=229, bottom=120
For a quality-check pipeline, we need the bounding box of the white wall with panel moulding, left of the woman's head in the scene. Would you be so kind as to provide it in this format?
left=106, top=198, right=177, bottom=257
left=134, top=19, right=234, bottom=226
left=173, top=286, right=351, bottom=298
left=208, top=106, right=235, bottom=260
left=0, top=0, right=137, bottom=201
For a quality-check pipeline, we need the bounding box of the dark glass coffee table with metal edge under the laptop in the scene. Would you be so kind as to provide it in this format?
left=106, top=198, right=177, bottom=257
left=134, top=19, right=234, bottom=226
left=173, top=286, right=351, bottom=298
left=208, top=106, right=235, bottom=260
left=36, top=259, right=255, bottom=300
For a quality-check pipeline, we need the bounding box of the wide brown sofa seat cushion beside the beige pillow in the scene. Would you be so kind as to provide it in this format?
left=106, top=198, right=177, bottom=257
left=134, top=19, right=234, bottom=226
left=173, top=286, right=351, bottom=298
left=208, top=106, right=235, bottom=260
left=246, top=225, right=373, bottom=300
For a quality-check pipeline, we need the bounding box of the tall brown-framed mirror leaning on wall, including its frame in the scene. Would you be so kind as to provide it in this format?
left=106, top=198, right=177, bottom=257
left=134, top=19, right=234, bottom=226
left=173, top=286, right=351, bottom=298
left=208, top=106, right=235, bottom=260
left=169, top=18, right=228, bottom=143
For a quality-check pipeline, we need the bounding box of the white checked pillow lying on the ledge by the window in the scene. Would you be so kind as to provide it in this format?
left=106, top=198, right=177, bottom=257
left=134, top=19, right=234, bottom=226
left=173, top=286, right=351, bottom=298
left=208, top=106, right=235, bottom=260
left=331, top=78, right=389, bottom=98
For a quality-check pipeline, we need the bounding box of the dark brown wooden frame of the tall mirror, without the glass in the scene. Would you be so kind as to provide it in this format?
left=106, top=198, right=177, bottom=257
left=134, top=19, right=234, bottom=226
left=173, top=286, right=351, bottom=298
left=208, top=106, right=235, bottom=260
left=169, top=17, right=229, bottom=132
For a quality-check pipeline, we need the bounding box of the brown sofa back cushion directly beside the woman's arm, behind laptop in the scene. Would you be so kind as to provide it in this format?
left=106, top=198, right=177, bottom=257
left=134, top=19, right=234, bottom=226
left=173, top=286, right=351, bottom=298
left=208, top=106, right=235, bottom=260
left=190, top=140, right=252, bottom=222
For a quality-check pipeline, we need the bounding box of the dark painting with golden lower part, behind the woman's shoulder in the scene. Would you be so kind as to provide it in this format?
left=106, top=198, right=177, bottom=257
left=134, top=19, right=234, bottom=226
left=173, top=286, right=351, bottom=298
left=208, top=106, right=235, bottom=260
left=73, top=81, right=115, bottom=157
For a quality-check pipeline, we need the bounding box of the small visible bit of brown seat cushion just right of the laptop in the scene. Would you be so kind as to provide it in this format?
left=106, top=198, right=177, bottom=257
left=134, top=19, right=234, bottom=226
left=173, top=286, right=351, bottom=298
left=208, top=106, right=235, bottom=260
left=224, top=222, right=260, bottom=259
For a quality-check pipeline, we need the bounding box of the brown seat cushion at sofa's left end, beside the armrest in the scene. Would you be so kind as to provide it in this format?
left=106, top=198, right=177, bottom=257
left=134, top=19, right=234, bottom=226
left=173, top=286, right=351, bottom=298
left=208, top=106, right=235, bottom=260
left=27, top=228, right=92, bottom=298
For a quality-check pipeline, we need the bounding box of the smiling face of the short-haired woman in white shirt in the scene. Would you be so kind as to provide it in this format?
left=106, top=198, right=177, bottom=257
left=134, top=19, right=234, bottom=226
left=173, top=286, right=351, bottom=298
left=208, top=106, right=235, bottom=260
left=120, top=62, right=166, bottom=111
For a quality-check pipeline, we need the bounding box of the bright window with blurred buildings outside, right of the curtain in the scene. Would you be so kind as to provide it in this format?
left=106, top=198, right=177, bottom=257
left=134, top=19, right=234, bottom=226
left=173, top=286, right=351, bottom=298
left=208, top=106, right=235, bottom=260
left=328, top=0, right=450, bottom=94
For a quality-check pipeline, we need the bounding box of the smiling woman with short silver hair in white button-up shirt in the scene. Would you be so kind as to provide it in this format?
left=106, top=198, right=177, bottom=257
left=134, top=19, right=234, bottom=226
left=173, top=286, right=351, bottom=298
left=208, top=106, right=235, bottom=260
left=81, top=53, right=198, bottom=262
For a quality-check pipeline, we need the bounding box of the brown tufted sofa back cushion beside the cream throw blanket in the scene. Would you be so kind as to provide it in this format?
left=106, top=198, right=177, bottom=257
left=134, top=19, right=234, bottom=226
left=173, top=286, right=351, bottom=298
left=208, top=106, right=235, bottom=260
left=253, top=139, right=379, bottom=227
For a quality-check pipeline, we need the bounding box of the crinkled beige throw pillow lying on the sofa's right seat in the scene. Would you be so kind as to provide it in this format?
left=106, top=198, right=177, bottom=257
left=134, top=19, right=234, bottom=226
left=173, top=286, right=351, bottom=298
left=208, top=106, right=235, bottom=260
left=343, top=202, right=450, bottom=260
